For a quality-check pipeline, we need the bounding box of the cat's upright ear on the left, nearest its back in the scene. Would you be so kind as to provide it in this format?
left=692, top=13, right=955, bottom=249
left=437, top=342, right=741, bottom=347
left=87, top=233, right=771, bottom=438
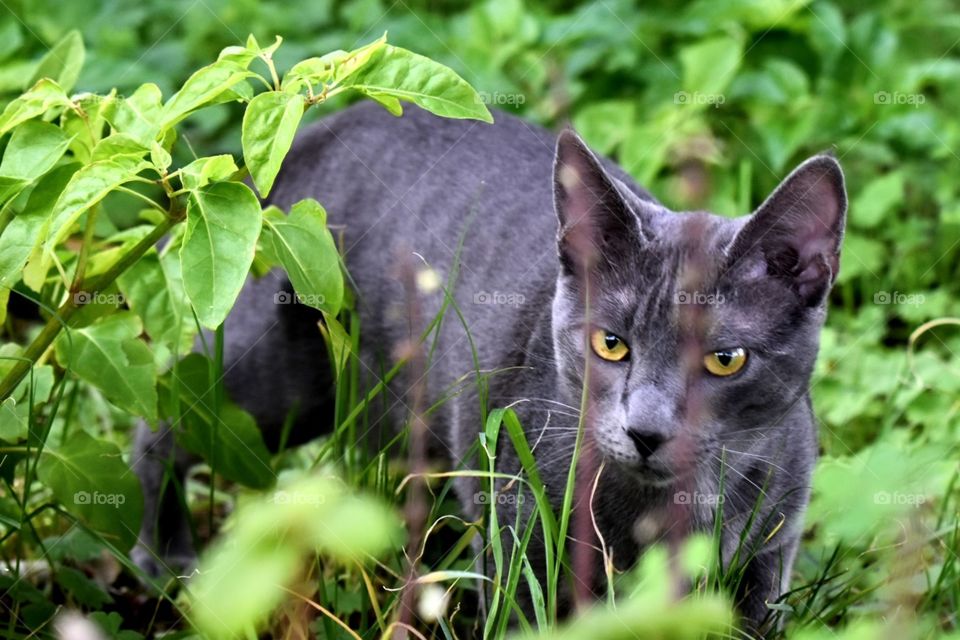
left=553, top=129, right=641, bottom=275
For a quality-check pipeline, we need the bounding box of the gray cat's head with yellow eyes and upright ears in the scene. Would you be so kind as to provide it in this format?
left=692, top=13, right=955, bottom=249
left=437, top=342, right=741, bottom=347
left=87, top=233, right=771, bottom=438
left=553, top=132, right=846, bottom=484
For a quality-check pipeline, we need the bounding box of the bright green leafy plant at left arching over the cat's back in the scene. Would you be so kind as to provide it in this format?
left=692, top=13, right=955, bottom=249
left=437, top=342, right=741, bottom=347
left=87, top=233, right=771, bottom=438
left=0, top=27, right=491, bottom=628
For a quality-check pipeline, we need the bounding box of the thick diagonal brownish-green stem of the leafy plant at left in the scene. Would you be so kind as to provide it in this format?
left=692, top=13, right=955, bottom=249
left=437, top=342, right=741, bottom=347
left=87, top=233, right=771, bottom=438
left=0, top=216, right=180, bottom=402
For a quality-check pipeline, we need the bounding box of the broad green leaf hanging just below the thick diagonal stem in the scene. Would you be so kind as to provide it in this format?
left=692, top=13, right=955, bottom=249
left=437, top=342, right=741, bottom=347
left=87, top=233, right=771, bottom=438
left=56, top=311, right=157, bottom=421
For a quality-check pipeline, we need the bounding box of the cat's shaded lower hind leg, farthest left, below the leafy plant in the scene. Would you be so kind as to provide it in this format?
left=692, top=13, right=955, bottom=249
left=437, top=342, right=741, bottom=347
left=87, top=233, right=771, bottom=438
left=130, top=422, right=197, bottom=578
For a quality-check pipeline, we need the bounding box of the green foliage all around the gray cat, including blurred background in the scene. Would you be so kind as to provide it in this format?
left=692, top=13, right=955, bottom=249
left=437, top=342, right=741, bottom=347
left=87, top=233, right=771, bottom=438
left=0, top=0, right=960, bottom=638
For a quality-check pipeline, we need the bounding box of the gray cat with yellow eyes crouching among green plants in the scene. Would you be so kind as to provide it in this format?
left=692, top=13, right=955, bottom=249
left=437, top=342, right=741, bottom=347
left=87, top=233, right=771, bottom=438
left=136, top=104, right=846, bottom=629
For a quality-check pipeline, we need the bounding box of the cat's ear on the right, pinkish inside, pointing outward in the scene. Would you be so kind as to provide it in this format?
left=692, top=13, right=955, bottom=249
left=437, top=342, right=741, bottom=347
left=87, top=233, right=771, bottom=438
left=728, top=155, right=847, bottom=307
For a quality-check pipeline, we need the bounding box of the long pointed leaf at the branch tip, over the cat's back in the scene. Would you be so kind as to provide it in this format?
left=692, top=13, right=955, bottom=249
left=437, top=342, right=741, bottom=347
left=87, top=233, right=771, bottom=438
left=341, top=45, right=493, bottom=122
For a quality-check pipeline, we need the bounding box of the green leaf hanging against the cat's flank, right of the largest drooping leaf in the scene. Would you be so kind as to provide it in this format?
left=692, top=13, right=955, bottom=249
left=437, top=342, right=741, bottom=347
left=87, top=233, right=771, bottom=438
left=264, top=199, right=343, bottom=315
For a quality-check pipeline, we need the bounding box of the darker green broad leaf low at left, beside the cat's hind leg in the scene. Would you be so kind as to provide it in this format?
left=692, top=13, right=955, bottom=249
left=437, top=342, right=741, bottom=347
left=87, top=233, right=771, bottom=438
left=37, top=428, right=143, bottom=550
